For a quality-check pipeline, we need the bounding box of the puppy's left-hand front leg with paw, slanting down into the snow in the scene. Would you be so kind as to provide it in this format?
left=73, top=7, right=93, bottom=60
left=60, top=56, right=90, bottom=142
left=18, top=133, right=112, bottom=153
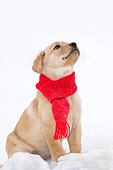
left=44, top=126, right=66, bottom=161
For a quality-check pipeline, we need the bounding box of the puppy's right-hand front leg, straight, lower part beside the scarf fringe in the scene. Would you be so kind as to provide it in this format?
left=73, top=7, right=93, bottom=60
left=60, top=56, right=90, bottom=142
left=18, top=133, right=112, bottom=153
left=68, top=118, right=82, bottom=153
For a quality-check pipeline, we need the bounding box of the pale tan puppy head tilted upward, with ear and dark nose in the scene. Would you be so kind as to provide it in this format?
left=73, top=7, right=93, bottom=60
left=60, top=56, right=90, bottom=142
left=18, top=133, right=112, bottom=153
left=32, top=41, right=80, bottom=77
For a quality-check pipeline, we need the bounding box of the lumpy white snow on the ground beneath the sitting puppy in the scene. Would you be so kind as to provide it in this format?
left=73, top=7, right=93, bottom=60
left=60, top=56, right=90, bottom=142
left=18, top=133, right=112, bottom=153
left=2, top=138, right=113, bottom=170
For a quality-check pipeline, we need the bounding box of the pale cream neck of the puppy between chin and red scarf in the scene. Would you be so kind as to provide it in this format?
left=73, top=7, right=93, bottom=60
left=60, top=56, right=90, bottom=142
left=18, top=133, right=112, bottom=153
left=42, top=65, right=73, bottom=80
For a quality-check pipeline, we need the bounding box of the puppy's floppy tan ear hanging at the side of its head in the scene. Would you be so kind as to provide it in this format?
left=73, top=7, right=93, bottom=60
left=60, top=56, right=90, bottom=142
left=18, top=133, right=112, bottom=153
left=32, top=51, right=45, bottom=74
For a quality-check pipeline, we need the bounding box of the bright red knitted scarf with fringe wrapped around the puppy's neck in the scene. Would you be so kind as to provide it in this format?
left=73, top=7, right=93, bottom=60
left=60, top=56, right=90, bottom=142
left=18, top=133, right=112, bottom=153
left=36, top=72, right=77, bottom=140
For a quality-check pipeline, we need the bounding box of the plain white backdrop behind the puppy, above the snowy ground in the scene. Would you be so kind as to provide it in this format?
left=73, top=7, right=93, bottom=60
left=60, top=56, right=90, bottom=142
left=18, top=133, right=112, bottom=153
left=0, top=0, right=113, bottom=164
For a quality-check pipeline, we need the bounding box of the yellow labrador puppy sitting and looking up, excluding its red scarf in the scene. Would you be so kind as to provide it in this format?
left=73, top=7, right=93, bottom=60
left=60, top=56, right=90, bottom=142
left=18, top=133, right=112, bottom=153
left=6, top=41, right=81, bottom=161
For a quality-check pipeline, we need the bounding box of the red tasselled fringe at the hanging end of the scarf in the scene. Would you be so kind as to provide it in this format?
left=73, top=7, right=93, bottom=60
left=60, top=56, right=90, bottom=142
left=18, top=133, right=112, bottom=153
left=53, top=122, right=70, bottom=140
